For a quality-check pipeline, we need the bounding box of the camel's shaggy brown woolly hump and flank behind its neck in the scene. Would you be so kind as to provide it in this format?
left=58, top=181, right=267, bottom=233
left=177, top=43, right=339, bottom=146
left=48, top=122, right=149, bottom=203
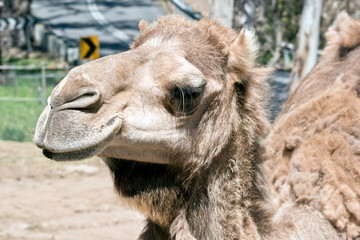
left=263, top=13, right=360, bottom=239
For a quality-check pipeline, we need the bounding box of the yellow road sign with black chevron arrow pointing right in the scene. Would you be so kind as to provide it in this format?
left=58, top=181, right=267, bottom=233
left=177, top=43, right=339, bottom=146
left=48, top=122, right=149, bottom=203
left=80, top=36, right=100, bottom=60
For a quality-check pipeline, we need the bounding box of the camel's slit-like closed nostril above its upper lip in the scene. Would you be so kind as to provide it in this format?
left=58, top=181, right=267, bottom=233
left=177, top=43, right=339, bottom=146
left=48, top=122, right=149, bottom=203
left=51, top=88, right=101, bottom=110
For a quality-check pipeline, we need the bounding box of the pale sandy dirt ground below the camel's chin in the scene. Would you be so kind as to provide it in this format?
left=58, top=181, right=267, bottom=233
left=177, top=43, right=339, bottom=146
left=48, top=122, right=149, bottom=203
left=0, top=141, right=144, bottom=240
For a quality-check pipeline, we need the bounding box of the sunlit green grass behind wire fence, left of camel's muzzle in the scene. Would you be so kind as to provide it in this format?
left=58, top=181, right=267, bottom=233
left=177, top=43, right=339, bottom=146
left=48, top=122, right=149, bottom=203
left=0, top=68, right=66, bottom=142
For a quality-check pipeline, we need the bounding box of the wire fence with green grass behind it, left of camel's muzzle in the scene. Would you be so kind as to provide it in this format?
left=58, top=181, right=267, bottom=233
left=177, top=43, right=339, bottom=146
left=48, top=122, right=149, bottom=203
left=0, top=64, right=69, bottom=141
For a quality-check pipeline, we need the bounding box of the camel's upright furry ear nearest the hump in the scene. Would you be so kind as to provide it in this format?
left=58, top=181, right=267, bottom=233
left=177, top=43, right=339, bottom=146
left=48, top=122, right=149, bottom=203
left=228, top=29, right=259, bottom=75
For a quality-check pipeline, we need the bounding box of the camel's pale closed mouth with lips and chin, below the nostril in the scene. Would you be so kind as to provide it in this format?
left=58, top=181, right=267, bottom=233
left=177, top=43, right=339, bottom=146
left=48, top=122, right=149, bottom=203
left=34, top=106, right=122, bottom=161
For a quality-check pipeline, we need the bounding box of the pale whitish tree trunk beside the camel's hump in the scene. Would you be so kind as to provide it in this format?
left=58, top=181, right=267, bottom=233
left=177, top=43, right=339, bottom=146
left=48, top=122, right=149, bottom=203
left=290, top=0, right=322, bottom=93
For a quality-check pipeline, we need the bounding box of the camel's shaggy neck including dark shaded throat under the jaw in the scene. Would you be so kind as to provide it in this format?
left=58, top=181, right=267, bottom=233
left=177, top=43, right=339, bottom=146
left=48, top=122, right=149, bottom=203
left=105, top=140, right=263, bottom=239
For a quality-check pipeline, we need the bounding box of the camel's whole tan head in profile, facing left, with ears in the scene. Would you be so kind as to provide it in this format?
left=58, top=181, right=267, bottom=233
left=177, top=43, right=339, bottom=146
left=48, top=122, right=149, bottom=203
left=34, top=16, right=266, bottom=169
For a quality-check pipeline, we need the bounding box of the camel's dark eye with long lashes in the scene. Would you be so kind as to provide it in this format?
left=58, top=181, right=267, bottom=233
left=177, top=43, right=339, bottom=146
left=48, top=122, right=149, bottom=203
left=170, top=86, right=204, bottom=115
